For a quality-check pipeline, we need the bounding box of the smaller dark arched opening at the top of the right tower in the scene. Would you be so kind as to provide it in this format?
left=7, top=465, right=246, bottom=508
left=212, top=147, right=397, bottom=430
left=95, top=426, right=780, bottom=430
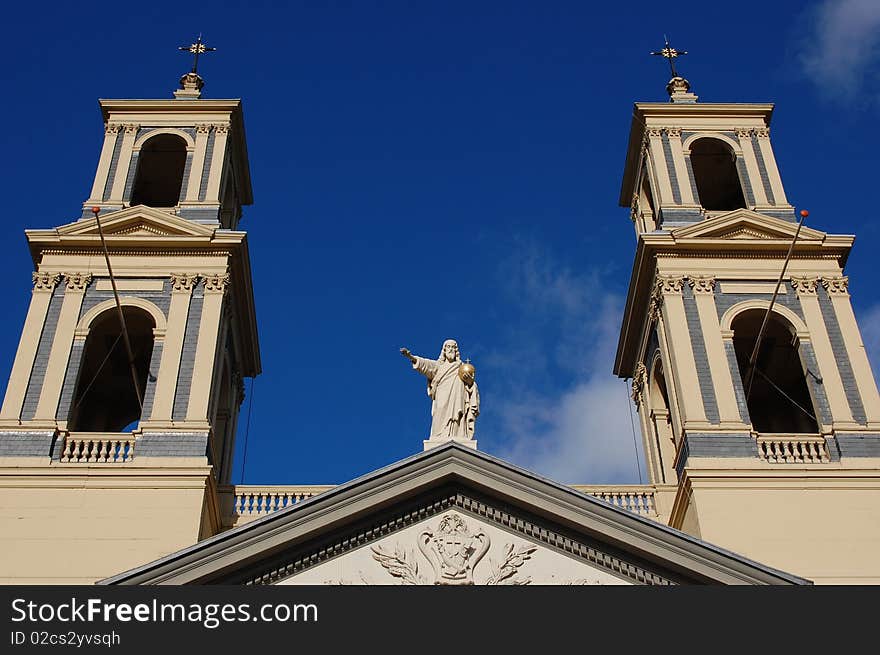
left=691, top=137, right=746, bottom=211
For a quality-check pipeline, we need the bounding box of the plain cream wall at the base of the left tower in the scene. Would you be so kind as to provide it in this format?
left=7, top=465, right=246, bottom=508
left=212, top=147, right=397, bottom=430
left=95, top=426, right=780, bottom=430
left=0, top=458, right=210, bottom=584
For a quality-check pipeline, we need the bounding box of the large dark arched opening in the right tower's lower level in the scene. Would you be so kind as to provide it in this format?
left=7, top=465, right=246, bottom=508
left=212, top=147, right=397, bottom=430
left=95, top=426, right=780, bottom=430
left=731, top=309, right=819, bottom=434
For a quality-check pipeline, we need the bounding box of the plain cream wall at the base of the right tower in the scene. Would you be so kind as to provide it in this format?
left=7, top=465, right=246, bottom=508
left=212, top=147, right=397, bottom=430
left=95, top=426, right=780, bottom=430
left=672, top=466, right=880, bottom=584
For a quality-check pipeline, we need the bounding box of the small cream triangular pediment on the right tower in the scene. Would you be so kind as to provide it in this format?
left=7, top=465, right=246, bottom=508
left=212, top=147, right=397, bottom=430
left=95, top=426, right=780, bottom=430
left=672, top=209, right=826, bottom=241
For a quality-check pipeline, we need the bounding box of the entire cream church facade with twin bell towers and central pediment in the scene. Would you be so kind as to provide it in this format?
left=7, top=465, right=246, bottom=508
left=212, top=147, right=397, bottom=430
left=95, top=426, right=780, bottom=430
left=0, top=50, right=880, bottom=585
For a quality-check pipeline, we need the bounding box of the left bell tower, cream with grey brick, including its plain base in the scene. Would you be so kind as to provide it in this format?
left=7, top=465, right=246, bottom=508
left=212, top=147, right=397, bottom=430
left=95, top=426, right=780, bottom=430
left=0, top=53, right=260, bottom=583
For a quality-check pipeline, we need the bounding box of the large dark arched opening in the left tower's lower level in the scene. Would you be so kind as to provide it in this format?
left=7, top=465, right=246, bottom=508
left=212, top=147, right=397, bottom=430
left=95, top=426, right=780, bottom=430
left=68, top=306, right=155, bottom=432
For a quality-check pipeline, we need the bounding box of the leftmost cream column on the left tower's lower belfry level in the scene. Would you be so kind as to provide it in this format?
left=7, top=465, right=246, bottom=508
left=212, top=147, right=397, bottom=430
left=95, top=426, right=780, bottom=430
left=0, top=273, right=61, bottom=424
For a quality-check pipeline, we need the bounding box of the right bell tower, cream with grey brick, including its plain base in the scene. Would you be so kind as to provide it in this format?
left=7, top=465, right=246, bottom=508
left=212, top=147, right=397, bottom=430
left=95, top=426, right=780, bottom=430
left=614, top=55, right=880, bottom=582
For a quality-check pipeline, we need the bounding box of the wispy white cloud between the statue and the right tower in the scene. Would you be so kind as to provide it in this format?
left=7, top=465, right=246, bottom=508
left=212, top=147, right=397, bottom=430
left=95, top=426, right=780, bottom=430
left=477, top=242, right=644, bottom=484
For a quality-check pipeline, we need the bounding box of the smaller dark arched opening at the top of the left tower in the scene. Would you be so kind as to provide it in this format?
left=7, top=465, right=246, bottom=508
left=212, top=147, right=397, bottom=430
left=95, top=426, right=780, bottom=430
left=131, top=134, right=186, bottom=207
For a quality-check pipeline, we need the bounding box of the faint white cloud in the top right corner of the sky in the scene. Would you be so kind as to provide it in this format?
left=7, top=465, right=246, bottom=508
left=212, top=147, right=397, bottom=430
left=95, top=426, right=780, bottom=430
left=801, top=0, right=880, bottom=95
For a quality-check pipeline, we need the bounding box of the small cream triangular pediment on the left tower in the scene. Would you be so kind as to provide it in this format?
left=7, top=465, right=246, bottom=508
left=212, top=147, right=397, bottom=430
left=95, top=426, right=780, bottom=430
left=56, top=205, right=214, bottom=239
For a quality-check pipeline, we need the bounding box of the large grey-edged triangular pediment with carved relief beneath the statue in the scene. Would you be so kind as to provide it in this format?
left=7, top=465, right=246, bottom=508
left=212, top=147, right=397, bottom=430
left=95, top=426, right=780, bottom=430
left=99, top=443, right=806, bottom=585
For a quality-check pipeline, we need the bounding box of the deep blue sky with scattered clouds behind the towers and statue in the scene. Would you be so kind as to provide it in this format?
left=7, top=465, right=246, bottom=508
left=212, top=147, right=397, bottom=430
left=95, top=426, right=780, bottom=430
left=0, top=0, right=880, bottom=484
